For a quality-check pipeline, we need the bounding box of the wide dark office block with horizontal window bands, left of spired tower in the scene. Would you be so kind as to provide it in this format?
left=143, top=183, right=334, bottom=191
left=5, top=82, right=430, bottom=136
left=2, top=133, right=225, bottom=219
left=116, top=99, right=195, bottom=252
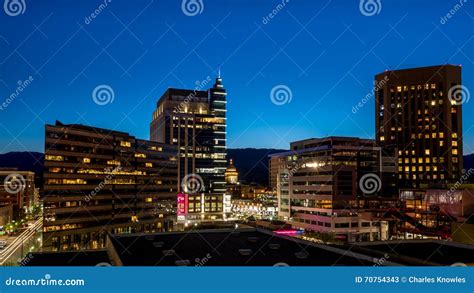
left=43, top=122, right=178, bottom=251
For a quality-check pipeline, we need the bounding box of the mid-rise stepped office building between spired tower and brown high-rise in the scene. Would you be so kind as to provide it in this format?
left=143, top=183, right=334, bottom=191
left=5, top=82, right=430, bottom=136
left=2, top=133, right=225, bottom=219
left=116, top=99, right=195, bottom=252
left=270, top=137, right=397, bottom=242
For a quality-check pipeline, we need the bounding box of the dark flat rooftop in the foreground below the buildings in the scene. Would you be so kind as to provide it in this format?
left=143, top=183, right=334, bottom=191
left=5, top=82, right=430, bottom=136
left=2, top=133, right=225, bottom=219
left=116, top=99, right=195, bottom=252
left=27, top=228, right=388, bottom=266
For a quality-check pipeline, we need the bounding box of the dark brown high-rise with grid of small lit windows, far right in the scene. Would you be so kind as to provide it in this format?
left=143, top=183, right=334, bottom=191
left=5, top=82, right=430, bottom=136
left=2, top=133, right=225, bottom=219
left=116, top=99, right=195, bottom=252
left=375, top=65, right=463, bottom=188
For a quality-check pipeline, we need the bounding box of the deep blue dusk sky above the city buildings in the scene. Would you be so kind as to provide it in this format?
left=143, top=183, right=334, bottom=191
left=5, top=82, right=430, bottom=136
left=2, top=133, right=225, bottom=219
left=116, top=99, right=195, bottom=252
left=0, top=0, right=474, bottom=153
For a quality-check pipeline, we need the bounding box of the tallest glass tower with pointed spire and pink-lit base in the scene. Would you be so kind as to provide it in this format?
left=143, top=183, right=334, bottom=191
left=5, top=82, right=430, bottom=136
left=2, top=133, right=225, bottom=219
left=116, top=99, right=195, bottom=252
left=150, top=75, right=230, bottom=222
